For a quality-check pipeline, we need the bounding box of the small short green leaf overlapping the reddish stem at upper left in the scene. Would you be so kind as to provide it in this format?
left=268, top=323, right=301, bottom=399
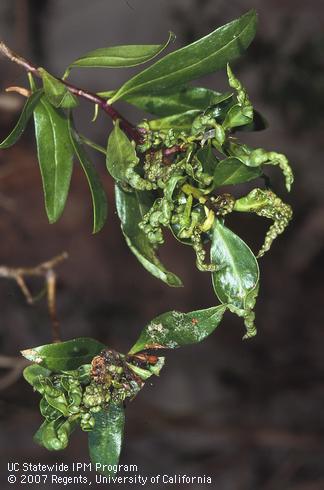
left=38, top=68, right=79, bottom=109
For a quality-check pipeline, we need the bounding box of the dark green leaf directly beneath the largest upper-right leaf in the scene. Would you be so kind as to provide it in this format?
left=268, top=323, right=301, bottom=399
left=124, top=86, right=232, bottom=117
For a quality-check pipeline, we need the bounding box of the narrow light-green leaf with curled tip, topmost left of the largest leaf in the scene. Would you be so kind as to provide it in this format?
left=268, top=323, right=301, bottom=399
left=70, top=32, right=175, bottom=68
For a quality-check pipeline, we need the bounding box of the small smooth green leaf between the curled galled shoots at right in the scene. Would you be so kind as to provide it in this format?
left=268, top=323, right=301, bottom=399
left=214, top=157, right=262, bottom=187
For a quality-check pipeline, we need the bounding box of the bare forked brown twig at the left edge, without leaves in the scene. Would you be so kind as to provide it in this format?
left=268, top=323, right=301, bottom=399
left=0, top=252, right=68, bottom=342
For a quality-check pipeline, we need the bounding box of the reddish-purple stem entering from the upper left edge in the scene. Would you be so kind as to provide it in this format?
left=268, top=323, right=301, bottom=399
left=0, top=41, right=142, bottom=143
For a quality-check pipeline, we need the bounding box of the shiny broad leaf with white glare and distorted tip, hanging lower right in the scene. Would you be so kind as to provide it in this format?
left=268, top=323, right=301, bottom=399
left=210, top=220, right=259, bottom=338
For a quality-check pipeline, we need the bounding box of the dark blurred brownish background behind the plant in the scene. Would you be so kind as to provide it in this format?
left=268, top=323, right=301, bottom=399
left=0, top=0, right=324, bottom=490
